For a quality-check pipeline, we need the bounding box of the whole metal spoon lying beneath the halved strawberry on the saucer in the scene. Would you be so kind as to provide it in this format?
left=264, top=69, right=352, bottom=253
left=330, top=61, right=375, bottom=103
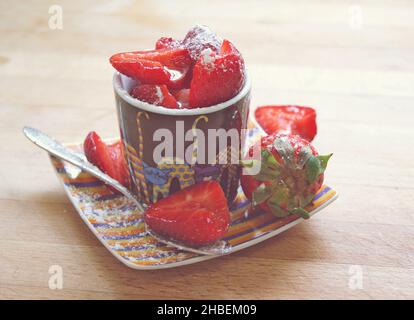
left=23, top=127, right=231, bottom=255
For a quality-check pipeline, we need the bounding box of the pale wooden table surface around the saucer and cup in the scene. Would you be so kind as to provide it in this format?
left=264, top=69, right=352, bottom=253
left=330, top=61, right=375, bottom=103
left=0, top=0, right=414, bottom=299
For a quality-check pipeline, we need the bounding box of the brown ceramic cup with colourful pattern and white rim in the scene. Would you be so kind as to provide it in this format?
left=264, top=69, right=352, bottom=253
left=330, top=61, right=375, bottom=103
left=113, top=73, right=250, bottom=204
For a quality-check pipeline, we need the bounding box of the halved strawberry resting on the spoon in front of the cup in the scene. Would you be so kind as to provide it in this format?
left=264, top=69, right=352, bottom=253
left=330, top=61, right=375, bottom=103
left=144, top=180, right=230, bottom=246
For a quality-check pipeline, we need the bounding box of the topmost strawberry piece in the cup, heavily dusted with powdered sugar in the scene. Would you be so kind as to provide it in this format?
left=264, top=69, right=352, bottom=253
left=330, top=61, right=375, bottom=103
left=182, top=25, right=222, bottom=63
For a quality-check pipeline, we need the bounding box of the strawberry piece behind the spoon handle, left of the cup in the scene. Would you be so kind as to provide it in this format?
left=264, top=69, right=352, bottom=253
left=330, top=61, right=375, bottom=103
left=83, top=131, right=130, bottom=191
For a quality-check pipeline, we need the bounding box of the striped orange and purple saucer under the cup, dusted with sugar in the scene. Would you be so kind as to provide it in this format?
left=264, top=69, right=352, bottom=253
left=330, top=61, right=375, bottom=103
left=51, top=144, right=338, bottom=270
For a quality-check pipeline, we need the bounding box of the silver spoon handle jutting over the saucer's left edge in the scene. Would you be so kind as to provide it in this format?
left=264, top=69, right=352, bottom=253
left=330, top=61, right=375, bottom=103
left=23, top=127, right=144, bottom=212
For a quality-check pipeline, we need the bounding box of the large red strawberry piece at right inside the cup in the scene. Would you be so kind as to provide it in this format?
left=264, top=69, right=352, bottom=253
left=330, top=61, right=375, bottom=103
left=189, top=40, right=245, bottom=108
